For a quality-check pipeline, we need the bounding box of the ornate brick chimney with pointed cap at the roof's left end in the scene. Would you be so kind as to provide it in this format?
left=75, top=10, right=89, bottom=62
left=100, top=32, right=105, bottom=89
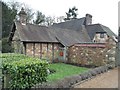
left=18, top=7, right=27, bottom=25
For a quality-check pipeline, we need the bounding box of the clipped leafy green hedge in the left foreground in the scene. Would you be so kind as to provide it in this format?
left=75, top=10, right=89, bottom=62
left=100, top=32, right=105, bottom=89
left=3, top=58, right=48, bottom=89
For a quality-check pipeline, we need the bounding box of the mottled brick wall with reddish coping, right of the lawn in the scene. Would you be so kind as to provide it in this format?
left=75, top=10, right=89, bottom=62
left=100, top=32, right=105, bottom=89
left=68, top=44, right=108, bottom=66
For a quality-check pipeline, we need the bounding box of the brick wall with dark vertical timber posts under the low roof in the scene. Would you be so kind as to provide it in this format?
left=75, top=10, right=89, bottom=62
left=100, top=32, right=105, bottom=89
left=26, top=43, right=59, bottom=62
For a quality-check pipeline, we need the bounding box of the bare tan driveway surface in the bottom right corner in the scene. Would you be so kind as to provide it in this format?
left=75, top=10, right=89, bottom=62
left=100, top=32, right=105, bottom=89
left=74, top=68, right=118, bottom=88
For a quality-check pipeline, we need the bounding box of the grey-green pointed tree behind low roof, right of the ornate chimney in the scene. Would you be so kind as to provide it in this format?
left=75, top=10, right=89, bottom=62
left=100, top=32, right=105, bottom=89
left=33, top=11, right=45, bottom=25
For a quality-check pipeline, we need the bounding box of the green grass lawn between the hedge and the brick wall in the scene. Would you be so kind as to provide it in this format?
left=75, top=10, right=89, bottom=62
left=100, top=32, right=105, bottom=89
left=48, top=63, right=89, bottom=82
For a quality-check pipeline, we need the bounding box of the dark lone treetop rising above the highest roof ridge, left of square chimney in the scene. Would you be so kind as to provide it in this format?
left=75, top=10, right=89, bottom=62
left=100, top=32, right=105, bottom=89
left=64, top=6, right=78, bottom=21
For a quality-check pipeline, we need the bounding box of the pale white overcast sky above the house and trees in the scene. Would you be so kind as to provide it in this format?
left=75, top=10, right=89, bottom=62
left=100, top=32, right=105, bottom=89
left=3, top=0, right=120, bottom=34
